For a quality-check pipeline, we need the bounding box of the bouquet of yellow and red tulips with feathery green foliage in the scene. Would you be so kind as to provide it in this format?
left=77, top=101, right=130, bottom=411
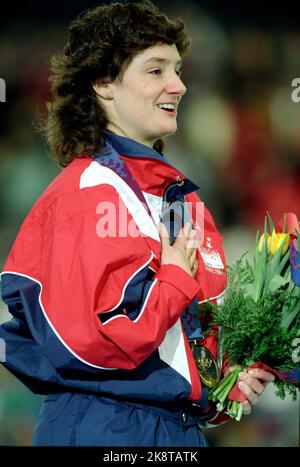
left=209, top=213, right=300, bottom=420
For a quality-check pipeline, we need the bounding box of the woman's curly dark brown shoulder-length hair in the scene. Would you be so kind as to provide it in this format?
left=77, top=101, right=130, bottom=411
left=42, top=0, right=190, bottom=167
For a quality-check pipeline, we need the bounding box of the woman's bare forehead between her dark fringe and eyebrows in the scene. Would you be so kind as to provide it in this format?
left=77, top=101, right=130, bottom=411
left=131, top=44, right=181, bottom=66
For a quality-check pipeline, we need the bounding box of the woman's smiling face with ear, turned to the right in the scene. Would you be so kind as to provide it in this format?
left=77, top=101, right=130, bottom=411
left=93, top=44, right=186, bottom=147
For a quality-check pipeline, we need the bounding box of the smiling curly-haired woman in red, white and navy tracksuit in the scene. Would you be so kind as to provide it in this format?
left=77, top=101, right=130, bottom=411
left=0, top=2, right=273, bottom=446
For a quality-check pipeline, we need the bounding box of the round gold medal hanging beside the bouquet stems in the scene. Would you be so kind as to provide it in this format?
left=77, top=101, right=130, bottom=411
left=189, top=339, right=220, bottom=388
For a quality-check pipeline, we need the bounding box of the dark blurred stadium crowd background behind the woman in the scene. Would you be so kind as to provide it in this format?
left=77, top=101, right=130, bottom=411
left=0, top=0, right=300, bottom=446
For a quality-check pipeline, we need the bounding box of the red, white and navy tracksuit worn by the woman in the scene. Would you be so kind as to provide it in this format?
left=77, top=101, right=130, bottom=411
left=0, top=131, right=227, bottom=446
